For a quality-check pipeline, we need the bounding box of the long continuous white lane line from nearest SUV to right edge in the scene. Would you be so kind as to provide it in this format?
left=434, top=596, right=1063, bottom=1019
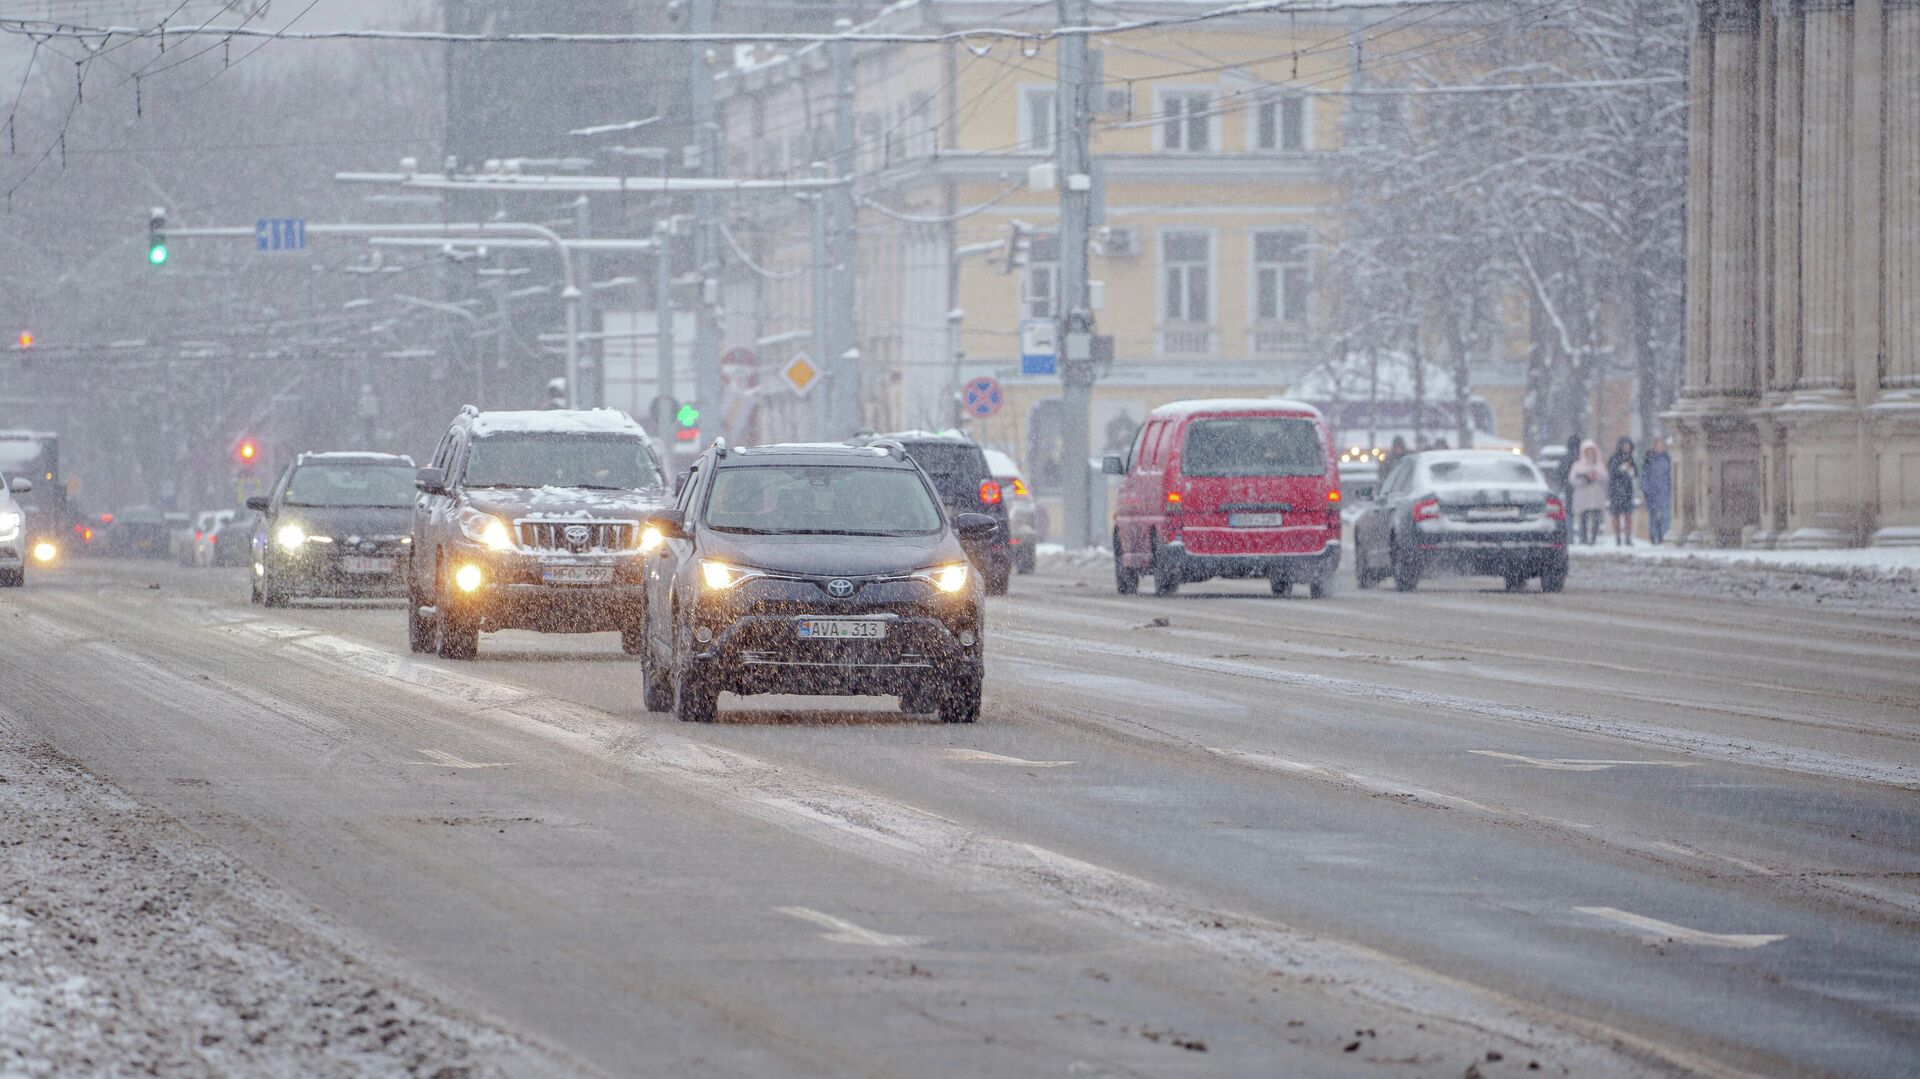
left=995, top=630, right=1920, bottom=789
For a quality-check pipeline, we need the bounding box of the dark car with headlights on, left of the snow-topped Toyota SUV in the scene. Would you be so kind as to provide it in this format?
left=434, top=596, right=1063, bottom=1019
left=246, top=453, right=413, bottom=607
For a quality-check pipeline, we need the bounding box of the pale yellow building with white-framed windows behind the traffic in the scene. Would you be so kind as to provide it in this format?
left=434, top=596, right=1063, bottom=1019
left=718, top=0, right=1436, bottom=478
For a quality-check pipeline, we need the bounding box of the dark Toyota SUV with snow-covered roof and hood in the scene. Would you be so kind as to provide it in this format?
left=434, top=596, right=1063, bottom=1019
left=407, top=405, right=666, bottom=659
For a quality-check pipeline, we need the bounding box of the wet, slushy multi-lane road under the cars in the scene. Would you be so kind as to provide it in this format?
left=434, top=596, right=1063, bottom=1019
left=0, top=563, right=1920, bottom=1075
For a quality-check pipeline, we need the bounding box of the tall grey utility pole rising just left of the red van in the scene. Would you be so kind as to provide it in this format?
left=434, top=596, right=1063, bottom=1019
left=1054, top=0, right=1094, bottom=547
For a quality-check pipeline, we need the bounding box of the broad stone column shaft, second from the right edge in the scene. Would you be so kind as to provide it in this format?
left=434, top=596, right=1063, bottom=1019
left=1799, top=0, right=1853, bottom=390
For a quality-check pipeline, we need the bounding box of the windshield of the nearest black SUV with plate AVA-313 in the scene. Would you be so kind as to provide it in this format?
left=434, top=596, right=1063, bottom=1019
left=707, top=465, right=941, bottom=536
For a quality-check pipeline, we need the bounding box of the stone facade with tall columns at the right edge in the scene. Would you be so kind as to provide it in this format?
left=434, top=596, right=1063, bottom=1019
left=1667, top=0, right=1920, bottom=547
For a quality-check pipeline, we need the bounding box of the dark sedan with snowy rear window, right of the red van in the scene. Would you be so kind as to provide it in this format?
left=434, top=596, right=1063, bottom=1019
left=1354, top=449, right=1567, bottom=591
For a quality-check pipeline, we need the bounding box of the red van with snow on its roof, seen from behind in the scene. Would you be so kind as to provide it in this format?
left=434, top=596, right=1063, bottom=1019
left=1104, top=399, right=1340, bottom=599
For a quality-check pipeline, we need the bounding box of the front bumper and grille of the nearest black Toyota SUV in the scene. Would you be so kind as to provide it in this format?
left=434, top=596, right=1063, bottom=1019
left=689, top=580, right=985, bottom=695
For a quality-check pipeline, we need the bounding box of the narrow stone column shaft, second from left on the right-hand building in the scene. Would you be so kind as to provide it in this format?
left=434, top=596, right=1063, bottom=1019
left=1761, top=0, right=1807, bottom=392
